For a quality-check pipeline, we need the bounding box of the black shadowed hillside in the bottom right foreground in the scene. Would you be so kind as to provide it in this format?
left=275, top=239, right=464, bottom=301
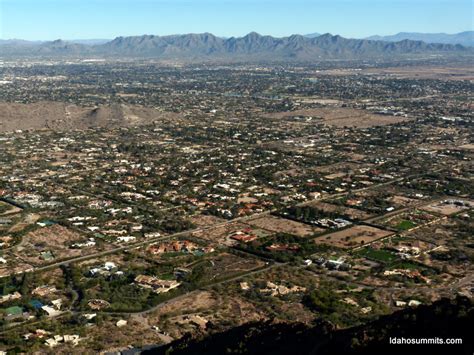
left=144, top=297, right=474, bottom=355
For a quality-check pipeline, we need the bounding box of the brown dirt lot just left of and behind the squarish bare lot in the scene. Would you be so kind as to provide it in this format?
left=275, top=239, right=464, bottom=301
left=247, top=216, right=324, bottom=237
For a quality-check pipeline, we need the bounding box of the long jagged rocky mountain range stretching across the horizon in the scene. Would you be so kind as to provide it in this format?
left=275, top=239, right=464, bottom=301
left=0, top=32, right=473, bottom=61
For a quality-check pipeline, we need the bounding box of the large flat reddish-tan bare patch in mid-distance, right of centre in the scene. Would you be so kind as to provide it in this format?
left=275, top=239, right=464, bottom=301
left=267, top=107, right=409, bottom=128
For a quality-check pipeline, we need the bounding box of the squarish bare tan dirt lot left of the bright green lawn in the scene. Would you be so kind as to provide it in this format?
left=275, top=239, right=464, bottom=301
left=315, top=226, right=394, bottom=249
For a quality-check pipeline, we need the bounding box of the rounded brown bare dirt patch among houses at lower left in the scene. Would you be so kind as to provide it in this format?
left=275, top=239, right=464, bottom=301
left=15, top=224, right=90, bottom=265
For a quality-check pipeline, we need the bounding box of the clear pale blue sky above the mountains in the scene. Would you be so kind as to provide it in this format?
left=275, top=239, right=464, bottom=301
left=0, top=0, right=474, bottom=40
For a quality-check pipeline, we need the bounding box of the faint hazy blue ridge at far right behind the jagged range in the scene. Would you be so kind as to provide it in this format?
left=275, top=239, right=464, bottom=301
left=366, top=31, right=474, bottom=47
